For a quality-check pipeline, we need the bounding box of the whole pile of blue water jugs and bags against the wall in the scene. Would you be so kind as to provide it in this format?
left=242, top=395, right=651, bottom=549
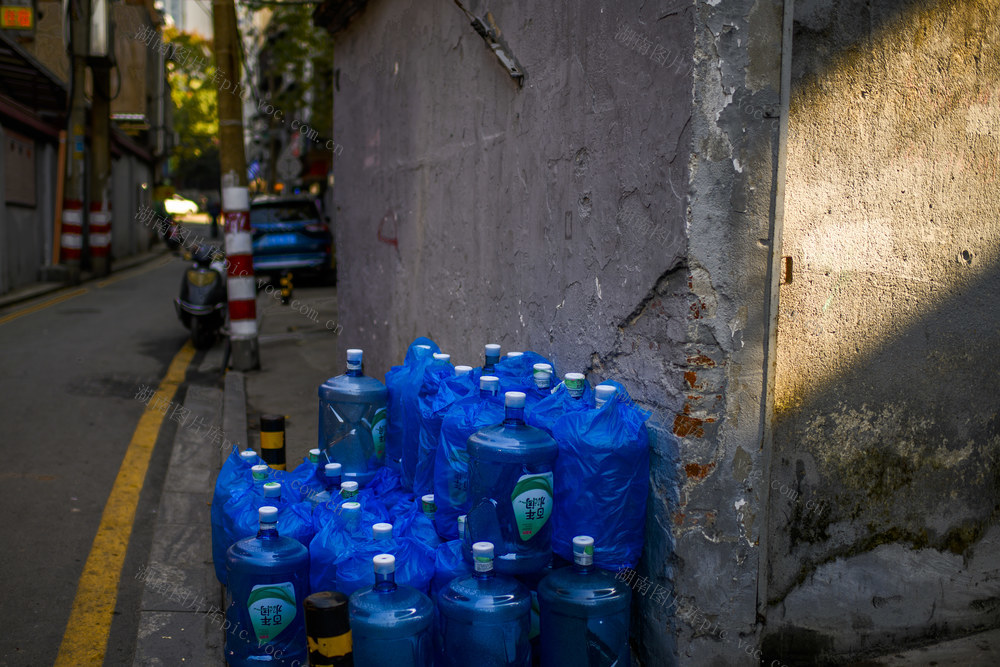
left=212, top=338, right=649, bottom=667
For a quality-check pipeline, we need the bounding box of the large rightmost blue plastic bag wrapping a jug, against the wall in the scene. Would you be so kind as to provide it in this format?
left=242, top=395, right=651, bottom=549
left=552, top=382, right=649, bottom=572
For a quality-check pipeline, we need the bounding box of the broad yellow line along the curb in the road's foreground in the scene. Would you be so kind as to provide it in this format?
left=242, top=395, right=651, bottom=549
left=55, top=341, right=194, bottom=667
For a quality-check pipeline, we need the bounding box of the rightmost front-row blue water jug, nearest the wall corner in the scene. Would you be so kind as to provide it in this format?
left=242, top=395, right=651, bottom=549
left=538, top=535, right=632, bottom=667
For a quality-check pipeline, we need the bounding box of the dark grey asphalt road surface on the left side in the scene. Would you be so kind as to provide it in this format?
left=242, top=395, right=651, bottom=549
left=0, top=256, right=209, bottom=665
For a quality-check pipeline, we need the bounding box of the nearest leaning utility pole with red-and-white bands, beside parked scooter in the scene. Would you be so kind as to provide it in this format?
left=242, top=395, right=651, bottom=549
left=212, top=0, right=260, bottom=371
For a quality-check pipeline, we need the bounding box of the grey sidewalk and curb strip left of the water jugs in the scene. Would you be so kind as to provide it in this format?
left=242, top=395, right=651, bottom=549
left=133, top=280, right=344, bottom=667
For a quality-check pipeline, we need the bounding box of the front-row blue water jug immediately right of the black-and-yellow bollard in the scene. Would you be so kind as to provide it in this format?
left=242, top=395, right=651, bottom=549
left=349, top=554, right=434, bottom=667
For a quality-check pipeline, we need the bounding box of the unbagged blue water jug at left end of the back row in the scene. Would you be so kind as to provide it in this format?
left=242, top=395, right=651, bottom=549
left=319, top=349, right=388, bottom=486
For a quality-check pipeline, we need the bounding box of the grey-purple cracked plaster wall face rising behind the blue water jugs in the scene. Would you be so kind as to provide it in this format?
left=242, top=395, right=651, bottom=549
left=331, top=0, right=696, bottom=665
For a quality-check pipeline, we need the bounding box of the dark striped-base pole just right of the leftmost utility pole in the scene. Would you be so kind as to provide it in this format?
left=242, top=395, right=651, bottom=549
left=87, top=62, right=111, bottom=276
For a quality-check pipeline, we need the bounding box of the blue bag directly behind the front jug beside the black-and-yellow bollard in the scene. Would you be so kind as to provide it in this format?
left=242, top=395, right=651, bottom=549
left=331, top=535, right=434, bottom=596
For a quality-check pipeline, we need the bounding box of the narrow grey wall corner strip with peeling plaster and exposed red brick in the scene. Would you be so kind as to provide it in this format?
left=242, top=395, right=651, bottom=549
left=673, top=0, right=783, bottom=665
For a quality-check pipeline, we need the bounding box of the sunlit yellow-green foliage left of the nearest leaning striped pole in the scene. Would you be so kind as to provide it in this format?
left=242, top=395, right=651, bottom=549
left=163, top=26, right=219, bottom=189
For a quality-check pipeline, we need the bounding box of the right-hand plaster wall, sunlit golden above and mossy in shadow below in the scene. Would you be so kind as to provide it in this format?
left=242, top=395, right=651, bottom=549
left=767, top=0, right=1000, bottom=664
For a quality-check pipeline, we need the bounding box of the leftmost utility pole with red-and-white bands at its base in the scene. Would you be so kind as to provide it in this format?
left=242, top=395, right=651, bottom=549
left=60, top=0, right=90, bottom=283
